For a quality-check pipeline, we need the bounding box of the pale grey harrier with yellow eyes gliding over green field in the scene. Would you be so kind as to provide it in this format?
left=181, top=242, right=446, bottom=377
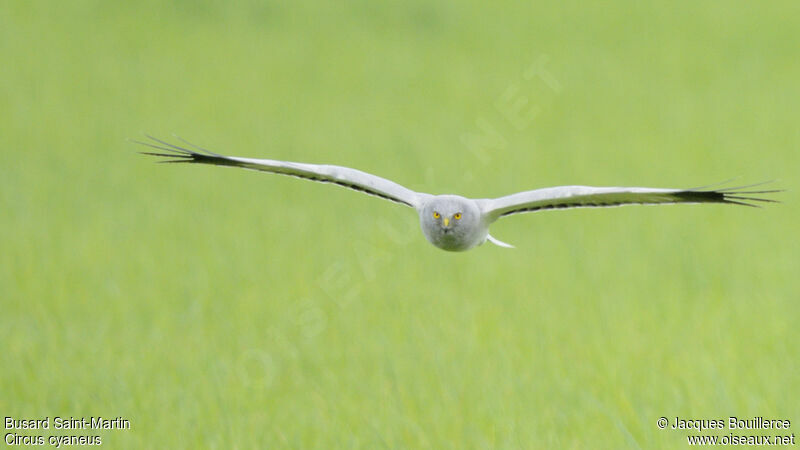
left=139, top=136, right=781, bottom=252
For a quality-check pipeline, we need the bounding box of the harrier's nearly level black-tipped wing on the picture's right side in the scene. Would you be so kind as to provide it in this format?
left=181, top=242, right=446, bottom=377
left=478, top=183, right=780, bottom=221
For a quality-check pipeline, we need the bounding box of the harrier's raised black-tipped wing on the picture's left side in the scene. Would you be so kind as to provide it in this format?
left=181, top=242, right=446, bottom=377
left=134, top=136, right=426, bottom=208
